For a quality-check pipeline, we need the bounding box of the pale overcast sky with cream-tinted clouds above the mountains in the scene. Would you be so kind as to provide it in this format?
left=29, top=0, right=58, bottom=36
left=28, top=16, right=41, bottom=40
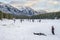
left=0, top=0, right=60, bottom=11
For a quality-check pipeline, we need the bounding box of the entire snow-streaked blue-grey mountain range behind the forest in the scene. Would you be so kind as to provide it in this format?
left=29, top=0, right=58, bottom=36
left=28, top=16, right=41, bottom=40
left=0, top=2, right=45, bottom=16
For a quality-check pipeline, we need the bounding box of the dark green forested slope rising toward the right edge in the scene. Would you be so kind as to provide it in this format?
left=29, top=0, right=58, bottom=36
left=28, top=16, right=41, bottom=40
left=31, top=12, right=60, bottom=19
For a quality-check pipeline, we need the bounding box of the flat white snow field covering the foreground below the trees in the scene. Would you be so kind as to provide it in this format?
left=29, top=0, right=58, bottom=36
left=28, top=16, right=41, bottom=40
left=0, top=19, right=60, bottom=40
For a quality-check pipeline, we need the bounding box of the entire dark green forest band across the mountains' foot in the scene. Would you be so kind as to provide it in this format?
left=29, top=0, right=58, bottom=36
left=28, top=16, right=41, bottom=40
left=0, top=11, right=60, bottom=19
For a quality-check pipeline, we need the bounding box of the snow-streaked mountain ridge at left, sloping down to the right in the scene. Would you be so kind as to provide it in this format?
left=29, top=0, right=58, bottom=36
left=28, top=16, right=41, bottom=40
left=0, top=4, right=20, bottom=15
